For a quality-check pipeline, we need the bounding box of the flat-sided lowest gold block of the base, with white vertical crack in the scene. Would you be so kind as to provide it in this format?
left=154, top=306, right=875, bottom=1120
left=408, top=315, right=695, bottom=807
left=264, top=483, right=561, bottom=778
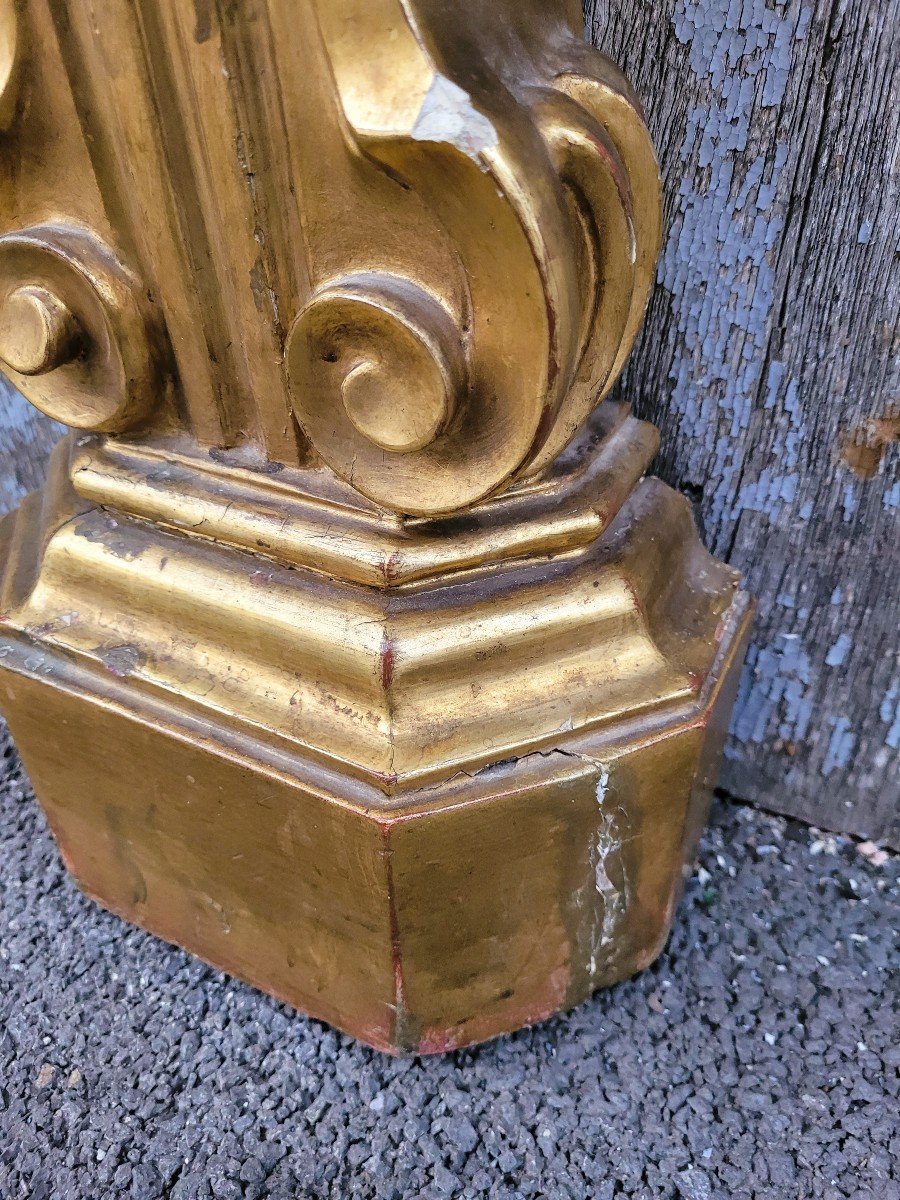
left=2, top=595, right=744, bottom=1052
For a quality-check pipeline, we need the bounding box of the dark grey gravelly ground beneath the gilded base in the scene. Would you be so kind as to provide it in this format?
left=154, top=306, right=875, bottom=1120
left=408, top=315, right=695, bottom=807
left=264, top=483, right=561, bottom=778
left=0, top=724, right=900, bottom=1200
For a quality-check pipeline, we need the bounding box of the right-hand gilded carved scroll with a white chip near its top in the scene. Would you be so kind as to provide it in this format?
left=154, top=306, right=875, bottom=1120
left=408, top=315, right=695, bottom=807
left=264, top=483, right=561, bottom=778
left=287, top=0, right=660, bottom=512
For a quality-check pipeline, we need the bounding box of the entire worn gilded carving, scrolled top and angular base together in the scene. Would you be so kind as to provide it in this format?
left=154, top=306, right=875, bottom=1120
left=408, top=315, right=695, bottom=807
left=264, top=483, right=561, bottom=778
left=0, top=0, right=749, bottom=1051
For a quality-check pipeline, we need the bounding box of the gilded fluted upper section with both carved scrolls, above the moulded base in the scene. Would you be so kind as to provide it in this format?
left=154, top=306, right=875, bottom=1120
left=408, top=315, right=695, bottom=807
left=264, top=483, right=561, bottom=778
left=0, top=0, right=660, bottom=515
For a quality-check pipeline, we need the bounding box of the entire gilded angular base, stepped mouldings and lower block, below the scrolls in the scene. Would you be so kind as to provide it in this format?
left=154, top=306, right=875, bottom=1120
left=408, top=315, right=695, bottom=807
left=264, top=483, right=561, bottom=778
left=0, top=425, right=750, bottom=1052
